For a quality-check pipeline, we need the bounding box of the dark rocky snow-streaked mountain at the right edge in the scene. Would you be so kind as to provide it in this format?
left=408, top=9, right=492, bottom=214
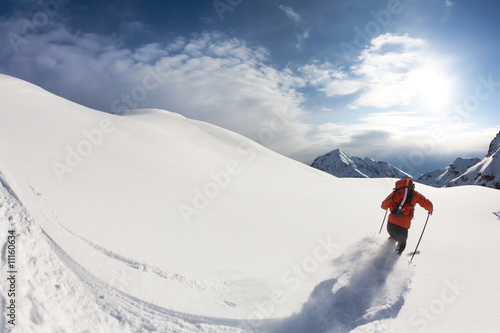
left=417, top=132, right=500, bottom=190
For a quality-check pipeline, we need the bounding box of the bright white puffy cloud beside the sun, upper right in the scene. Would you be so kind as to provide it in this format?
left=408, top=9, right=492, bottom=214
left=301, top=33, right=438, bottom=108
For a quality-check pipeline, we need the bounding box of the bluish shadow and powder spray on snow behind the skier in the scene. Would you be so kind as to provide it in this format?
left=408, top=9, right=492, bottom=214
left=260, top=239, right=407, bottom=333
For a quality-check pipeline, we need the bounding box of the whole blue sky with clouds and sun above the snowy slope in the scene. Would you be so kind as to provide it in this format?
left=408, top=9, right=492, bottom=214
left=0, top=0, right=500, bottom=176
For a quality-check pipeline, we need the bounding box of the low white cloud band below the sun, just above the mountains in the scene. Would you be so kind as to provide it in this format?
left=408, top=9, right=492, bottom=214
left=313, top=111, right=498, bottom=177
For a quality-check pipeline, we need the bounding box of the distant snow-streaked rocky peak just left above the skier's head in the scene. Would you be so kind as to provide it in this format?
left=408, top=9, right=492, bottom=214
left=311, top=149, right=409, bottom=178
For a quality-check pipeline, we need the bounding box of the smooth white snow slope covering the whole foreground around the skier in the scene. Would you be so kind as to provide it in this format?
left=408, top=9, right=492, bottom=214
left=0, top=76, right=500, bottom=333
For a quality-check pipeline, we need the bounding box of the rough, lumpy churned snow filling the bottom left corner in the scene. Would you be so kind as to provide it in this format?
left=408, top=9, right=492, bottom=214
left=0, top=178, right=250, bottom=333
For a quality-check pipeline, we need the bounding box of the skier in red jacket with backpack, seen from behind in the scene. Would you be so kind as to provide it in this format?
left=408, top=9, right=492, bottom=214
left=381, top=177, right=434, bottom=254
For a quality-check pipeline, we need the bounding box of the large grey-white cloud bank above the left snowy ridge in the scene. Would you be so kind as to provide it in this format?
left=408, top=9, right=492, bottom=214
left=0, top=25, right=309, bottom=156
